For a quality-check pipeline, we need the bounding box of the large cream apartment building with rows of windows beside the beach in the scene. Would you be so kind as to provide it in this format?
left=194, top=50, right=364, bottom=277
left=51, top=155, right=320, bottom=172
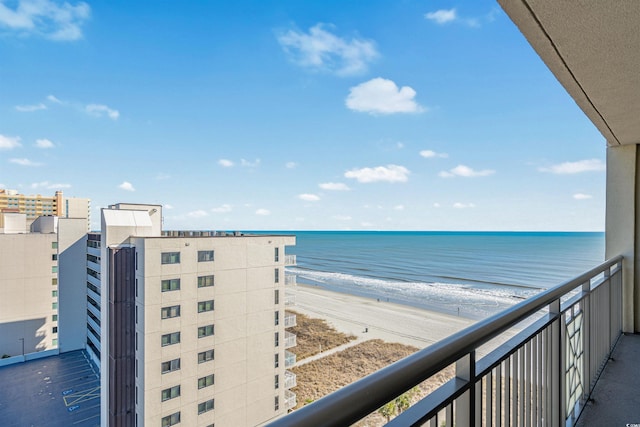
left=99, top=204, right=295, bottom=427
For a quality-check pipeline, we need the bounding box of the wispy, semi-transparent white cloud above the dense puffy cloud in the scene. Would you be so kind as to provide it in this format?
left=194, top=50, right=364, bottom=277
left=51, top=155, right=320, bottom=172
left=278, top=24, right=379, bottom=76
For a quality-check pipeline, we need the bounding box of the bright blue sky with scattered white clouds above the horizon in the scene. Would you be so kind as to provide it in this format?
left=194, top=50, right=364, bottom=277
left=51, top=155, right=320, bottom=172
left=0, top=0, right=606, bottom=231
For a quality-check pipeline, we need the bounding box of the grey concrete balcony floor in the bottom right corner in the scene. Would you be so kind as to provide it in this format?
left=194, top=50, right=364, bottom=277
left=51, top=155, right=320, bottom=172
left=577, top=334, right=640, bottom=427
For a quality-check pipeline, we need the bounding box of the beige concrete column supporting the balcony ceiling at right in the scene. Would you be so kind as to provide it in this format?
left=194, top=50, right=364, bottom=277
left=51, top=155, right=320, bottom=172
left=605, top=145, right=640, bottom=332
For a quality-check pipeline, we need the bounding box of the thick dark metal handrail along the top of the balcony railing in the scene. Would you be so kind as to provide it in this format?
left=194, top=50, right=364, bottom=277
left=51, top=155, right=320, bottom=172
left=269, top=256, right=622, bottom=427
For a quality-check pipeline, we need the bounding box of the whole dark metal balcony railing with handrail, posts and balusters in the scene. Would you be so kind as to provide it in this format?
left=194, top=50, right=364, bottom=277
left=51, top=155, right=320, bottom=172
left=270, top=257, right=622, bottom=426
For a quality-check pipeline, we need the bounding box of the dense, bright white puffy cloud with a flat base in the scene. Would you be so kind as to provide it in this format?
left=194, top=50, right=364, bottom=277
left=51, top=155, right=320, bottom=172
left=345, top=77, right=424, bottom=114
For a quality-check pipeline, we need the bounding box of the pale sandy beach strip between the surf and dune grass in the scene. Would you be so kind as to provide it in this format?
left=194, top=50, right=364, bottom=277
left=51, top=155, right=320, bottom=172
left=287, top=283, right=474, bottom=348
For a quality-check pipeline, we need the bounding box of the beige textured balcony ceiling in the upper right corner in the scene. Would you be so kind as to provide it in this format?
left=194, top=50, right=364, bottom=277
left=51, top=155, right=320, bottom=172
left=498, top=0, right=640, bottom=145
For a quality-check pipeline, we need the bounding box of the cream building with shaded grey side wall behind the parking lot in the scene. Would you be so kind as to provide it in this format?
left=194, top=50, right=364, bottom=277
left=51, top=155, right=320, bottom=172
left=0, top=213, right=86, bottom=362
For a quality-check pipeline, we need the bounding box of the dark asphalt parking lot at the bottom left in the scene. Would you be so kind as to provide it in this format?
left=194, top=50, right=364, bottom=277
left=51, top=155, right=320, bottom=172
left=0, top=350, right=100, bottom=427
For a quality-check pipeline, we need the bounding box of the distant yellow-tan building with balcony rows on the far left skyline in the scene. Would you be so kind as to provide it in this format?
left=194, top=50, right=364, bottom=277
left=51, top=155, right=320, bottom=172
left=0, top=189, right=91, bottom=231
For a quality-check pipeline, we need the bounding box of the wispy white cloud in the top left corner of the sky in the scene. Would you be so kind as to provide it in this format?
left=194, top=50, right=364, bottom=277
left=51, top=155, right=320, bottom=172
left=0, top=0, right=91, bottom=41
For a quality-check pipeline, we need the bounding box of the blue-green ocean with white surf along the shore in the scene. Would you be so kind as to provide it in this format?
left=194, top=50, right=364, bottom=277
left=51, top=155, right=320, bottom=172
left=270, top=231, right=604, bottom=319
